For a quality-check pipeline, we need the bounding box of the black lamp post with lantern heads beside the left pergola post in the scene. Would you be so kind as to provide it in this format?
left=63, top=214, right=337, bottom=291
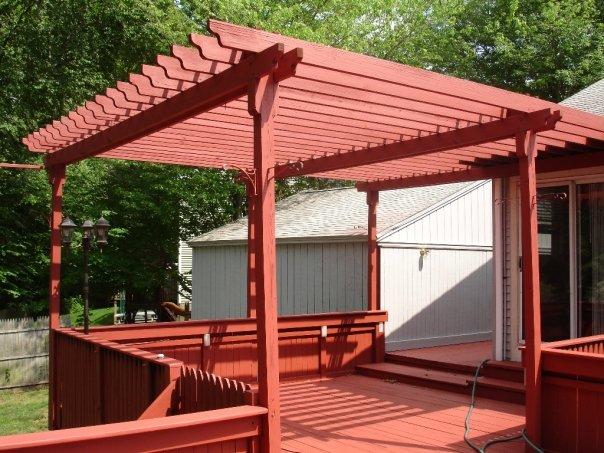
left=61, top=216, right=110, bottom=334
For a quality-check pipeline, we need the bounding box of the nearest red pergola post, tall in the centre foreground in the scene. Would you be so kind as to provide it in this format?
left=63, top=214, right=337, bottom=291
left=248, top=73, right=281, bottom=453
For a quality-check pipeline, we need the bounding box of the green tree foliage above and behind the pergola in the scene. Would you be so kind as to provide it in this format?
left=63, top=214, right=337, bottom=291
left=0, top=0, right=604, bottom=314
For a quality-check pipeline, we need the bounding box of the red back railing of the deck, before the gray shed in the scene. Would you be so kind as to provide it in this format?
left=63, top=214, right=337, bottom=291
left=86, top=311, right=387, bottom=383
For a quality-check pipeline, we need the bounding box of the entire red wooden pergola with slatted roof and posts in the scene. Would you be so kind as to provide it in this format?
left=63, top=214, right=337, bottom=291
left=23, top=21, right=604, bottom=451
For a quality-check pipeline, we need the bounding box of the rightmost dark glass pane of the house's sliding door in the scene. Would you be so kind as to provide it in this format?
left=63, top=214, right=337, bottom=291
left=576, top=183, right=604, bottom=336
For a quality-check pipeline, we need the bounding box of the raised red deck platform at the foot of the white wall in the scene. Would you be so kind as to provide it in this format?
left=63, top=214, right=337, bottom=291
left=390, top=341, right=492, bottom=366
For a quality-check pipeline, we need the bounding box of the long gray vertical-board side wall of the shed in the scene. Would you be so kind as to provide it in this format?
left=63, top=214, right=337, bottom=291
left=192, top=242, right=367, bottom=319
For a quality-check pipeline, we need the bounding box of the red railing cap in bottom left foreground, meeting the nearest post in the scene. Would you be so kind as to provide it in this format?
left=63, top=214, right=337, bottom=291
left=0, top=406, right=267, bottom=452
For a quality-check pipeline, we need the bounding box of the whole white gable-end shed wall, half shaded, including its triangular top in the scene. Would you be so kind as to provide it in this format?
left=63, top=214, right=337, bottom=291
left=380, top=181, right=493, bottom=350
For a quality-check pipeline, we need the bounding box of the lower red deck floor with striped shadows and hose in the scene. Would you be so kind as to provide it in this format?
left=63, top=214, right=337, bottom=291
left=281, top=375, right=524, bottom=453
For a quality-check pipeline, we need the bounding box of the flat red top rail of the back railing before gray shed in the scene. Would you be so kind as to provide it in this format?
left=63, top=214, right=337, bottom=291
left=84, top=311, right=388, bottom=342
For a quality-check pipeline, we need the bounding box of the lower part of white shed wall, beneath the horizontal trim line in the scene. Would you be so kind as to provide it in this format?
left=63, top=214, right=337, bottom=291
left=380, top=246, right=492, bottom=350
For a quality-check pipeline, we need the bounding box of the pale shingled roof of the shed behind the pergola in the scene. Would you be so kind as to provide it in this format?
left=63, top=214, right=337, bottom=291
left=189, top=182, right=476, bottom=246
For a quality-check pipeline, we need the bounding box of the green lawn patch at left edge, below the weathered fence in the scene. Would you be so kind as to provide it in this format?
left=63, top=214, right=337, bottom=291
left=0, top=388, right=48, bottom=436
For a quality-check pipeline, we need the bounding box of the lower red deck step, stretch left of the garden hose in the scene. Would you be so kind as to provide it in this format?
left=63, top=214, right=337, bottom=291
left=357, top=362, right=468, bottom=393
